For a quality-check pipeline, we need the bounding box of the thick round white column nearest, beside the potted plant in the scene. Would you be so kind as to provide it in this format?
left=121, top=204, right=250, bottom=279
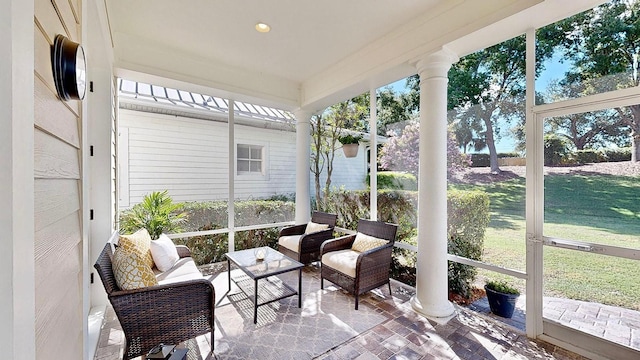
left=411, top=48, right=458, bottom=321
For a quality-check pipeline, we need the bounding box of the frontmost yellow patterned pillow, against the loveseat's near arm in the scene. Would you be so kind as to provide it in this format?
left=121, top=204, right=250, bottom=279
left=111, top=247, right=158, bottom=290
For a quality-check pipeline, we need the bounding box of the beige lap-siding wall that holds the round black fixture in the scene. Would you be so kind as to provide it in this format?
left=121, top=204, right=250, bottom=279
left=32, top=0, right=87, bottom=359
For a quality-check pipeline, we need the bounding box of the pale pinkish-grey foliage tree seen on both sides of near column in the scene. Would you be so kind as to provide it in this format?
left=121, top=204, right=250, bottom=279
left=380, top=121, right=469, bottom=178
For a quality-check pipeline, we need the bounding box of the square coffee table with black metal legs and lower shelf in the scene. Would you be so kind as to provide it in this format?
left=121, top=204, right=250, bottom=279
left=225, top=247, right=304, bottom=324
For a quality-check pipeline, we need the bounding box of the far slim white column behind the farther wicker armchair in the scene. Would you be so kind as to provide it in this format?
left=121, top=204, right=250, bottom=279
left=294, top=110, right=311, bottom=224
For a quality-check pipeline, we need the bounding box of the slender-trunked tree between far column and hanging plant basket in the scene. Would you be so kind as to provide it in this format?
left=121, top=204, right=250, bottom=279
left=311, top=93, right=369, bottom=210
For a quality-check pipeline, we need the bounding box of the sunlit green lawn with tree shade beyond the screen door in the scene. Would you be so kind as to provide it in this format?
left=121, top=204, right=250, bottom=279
left=451, top=175, right=640, bottom=310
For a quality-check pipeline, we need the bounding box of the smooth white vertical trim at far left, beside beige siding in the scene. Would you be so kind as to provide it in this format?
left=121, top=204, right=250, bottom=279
left=0, top=0, right=36, bottom=360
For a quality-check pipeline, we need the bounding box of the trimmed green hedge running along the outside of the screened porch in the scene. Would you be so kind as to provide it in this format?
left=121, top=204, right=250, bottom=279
left=127, top=190, right=489, bottom=296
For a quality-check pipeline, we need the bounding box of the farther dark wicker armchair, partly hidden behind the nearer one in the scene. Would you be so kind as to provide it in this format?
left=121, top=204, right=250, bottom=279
left=278, top=211, right=338, bottom=264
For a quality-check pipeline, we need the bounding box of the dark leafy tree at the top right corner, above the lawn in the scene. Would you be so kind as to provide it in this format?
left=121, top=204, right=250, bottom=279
left=550, top=0, right=640, bottom=161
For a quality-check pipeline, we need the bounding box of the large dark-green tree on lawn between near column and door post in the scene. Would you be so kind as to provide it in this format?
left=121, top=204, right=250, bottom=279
left=408, top=36, right=532, bottom=173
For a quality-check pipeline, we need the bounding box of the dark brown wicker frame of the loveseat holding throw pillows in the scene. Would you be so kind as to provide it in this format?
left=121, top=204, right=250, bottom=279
left=94, top=244, right=215, bottom=359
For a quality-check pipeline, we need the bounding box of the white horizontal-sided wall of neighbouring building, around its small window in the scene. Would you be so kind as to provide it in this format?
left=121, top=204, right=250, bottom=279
left=118, top=109, right=367, bottom=209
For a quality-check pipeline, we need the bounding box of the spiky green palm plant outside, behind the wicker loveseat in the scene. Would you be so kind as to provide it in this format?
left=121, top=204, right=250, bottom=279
left=120, top=190, right=186, bottom=239
